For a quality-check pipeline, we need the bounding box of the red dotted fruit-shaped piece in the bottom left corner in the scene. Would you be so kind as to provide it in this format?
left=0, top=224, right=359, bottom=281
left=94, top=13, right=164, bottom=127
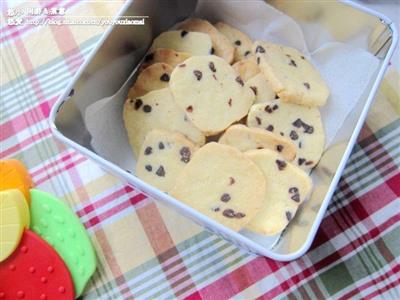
left=0, top=230, right=74, bottom=300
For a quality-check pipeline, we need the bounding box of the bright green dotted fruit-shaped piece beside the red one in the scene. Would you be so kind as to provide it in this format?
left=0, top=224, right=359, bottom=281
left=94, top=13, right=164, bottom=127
left=31, top=189, right=96, bottom=297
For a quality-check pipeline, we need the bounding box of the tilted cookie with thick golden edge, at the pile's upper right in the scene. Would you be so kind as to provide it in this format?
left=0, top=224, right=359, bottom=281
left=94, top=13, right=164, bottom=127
left=252, top=41, right=329, bottom=106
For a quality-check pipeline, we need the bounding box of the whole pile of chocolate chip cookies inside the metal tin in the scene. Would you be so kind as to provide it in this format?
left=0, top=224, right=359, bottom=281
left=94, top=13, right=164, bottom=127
left=123, top=18, right=329, bottom=235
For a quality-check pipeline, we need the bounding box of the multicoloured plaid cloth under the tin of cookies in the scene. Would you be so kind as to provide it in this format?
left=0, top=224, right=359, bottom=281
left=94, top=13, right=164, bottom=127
left=0, top=0, right=400, bottom=299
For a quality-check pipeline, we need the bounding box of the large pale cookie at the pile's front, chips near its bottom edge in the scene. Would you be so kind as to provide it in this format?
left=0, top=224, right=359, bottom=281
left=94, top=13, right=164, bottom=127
left=170, top=143, right=265, bottom=231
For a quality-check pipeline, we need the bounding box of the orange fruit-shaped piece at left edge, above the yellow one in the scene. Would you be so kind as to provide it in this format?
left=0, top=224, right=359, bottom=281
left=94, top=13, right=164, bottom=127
left=0, top=159, right=34, bottom=204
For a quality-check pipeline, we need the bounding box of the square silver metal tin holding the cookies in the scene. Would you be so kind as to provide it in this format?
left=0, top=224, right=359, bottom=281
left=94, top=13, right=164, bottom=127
left=50, top=0, right=397, bottom=261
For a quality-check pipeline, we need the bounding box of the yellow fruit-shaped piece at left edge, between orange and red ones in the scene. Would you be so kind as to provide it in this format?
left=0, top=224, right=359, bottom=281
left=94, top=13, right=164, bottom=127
left=0, top=190, right=30, bottom=262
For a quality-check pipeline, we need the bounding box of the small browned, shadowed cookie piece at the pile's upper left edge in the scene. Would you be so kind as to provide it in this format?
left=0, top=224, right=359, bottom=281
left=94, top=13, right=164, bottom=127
left=128, top=63, right=173, bottom=98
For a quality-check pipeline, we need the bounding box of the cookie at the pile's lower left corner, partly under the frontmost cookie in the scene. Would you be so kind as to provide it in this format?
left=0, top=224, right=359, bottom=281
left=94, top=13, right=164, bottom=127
left=136, top=129, right=197, bottom=191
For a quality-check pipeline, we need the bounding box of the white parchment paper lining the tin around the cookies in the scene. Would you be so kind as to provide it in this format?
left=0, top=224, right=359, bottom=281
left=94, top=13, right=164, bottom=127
left=84, top=1, right=379, bottom=172
